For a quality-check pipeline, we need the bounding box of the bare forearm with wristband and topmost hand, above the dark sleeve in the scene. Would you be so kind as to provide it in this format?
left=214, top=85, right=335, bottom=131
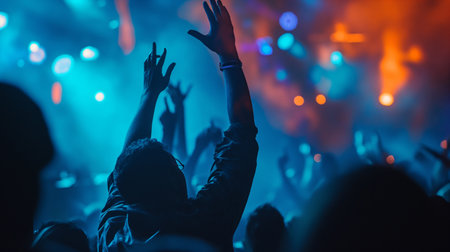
left=188, top=0, right=254, bottom=125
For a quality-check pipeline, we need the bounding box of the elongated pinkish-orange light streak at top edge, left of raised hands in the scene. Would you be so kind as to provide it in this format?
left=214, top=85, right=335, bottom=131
left=115, top=0, right=135, bottom=54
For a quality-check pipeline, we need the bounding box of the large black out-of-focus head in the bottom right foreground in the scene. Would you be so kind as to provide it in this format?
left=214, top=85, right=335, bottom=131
left=294, top=167, right=450, bottom=251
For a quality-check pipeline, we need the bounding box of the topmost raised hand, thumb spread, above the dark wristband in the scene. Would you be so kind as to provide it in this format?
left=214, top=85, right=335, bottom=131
left=188, top=0, right=237, bottom=58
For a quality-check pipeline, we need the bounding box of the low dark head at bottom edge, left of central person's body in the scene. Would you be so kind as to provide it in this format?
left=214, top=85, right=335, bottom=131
left=31, top=222, right=90, bottom=252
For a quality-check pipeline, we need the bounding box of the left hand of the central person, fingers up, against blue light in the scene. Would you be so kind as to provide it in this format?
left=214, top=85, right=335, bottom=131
left=144, top=43, right=175, bottom=96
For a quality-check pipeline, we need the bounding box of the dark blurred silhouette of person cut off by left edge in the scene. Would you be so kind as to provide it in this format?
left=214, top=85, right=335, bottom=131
left=0, top=83, right=53, bottom=251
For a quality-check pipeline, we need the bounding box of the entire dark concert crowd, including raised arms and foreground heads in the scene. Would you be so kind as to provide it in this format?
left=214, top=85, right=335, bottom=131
left=0, top=0, right=450, bottom=252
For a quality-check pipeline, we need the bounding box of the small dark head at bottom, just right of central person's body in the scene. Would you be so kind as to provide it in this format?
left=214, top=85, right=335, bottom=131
left=245, top=204, right=286, bottom=252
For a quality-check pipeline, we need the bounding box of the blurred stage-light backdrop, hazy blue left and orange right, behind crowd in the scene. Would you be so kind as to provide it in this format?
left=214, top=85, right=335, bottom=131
left=0, top=0, right=450, bottom=244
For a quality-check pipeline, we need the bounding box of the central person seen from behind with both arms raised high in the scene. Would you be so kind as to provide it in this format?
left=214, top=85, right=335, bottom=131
left=99, top=1, right=258, bottom=251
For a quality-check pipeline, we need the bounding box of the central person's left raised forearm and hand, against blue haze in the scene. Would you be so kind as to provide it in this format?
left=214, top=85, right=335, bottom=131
left=124, top=43, right=175, bottom=148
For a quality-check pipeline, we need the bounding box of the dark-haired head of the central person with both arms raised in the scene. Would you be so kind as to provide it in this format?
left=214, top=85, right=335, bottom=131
left=114, top=138, right=187, bottom=212
